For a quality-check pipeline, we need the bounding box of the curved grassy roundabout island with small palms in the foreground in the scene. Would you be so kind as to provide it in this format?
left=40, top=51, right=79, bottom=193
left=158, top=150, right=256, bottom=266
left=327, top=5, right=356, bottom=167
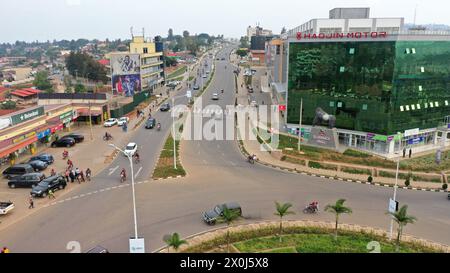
left=183, top=226, right=439, bottom=253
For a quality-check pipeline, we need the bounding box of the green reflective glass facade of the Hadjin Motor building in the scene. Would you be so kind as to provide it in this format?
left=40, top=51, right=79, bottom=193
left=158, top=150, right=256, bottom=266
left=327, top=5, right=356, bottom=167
left=287, top=41, right=450, bottom=135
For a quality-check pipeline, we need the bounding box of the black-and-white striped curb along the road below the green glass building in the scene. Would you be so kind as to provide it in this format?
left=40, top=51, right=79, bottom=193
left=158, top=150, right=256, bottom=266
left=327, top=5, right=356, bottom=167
left=237, top=133, right=448, bottom=193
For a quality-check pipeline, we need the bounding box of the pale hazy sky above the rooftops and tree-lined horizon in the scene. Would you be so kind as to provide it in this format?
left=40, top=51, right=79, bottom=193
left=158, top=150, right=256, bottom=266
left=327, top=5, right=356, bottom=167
left=0, top=0, right=450, bottom=42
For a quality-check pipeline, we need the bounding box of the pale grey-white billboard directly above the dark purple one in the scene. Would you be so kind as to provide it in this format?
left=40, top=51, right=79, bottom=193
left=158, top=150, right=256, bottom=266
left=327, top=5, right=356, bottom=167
left=111, top=53, right=141, bottom=76
